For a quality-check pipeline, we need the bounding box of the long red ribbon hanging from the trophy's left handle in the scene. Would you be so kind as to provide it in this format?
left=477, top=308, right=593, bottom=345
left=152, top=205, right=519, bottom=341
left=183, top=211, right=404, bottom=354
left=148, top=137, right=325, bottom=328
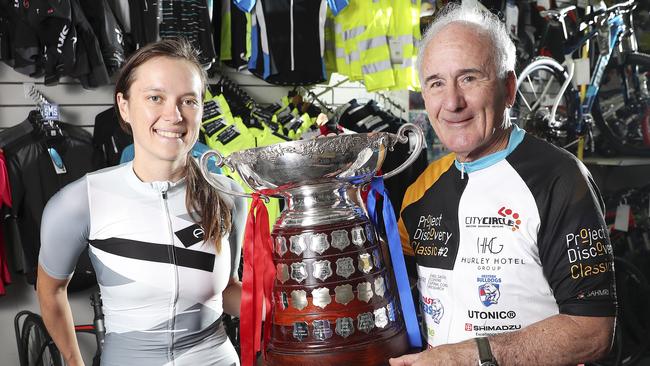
left=239, top=193, right=275, bottom=366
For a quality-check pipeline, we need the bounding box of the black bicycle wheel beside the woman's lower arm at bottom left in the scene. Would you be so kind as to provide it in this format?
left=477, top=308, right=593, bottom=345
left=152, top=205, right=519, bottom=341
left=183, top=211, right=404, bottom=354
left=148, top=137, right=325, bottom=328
left=21, top=314, right=64, bottom=366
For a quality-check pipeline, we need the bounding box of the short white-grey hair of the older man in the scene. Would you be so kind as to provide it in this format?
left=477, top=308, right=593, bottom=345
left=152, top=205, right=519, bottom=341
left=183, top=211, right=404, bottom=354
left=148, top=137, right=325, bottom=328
left=416, top=3, right=517, bottom=81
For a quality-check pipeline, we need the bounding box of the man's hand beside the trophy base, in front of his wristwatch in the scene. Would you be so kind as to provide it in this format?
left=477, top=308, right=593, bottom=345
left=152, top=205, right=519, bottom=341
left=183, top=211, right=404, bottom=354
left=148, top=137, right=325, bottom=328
left=389, top=339, right=478, bottom=366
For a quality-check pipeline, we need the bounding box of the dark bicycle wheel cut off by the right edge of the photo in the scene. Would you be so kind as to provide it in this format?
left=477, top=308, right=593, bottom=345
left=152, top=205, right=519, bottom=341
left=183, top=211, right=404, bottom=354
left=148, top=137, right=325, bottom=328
left=591, top=53, right=650, bottom=156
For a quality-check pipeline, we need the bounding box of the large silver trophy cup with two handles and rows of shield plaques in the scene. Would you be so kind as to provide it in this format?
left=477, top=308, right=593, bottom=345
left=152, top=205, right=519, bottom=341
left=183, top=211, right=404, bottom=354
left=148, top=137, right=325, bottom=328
left=200, top=124, right=424, bottom=366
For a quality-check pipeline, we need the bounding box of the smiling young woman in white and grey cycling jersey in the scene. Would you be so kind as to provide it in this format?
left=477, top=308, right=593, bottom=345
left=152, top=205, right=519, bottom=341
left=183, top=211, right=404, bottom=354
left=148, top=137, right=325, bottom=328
left=37, top=40, right=246, bottom=366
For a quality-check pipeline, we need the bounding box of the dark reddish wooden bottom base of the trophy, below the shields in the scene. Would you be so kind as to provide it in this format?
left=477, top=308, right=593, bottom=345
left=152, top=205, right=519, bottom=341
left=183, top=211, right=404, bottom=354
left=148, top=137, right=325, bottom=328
left=264, top=328, right=410, bottom=366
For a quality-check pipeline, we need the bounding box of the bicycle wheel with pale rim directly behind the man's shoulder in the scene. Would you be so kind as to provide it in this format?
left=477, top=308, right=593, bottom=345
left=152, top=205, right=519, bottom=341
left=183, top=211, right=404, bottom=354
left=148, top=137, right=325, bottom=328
left=510, top=57, right=576, bottom=147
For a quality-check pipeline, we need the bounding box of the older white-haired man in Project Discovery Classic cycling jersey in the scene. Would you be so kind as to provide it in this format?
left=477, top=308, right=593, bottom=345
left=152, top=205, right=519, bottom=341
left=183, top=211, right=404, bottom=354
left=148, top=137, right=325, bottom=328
left=390, top=6, right=616, bottom=366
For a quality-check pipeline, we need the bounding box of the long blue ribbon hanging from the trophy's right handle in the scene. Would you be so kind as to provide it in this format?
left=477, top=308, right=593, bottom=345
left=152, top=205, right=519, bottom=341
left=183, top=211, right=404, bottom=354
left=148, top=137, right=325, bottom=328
left=367, top=177, right=422, bottom=348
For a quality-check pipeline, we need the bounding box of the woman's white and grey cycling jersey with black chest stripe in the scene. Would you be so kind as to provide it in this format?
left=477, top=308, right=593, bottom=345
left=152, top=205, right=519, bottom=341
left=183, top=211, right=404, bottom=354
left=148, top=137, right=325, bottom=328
left=39, top=163, right=246, bottom=366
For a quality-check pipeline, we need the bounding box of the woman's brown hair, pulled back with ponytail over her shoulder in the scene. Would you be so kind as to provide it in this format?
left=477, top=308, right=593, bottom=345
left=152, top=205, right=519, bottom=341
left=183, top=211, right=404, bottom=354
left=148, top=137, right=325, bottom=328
left=114, top=38, right=232, bottom=252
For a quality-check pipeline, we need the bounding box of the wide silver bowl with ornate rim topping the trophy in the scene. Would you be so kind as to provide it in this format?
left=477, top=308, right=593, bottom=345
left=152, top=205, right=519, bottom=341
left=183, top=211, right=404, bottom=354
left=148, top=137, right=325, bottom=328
left=201, top=124, right=422, bottom=194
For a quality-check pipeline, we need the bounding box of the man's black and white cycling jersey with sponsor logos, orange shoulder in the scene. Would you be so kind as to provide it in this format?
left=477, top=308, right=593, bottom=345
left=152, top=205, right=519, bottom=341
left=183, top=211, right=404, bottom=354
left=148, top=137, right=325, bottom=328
left=399, top=126, right=616, bottom=346
